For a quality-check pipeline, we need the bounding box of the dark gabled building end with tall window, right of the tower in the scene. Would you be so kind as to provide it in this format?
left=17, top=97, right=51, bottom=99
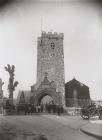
left=65, top=78, right=90, bottom=107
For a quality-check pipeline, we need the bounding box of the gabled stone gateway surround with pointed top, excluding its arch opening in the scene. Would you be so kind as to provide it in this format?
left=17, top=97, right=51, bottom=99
left=34, top=76, right=62, bottom=105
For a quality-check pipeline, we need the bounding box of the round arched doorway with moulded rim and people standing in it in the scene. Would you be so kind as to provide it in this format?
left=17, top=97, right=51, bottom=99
left=35, top=88, right=61, bottom=113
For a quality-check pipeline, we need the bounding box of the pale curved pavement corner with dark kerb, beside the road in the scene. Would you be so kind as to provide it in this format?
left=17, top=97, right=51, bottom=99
left=80, top=120, right=102, bottom=140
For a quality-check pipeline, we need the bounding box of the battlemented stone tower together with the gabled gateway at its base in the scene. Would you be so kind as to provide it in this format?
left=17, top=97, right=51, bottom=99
left=31, top=32, right=65, bottom=106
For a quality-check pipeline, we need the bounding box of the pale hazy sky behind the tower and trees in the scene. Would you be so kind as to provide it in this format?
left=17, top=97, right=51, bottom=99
left=0, top=0, right=102, bottom=100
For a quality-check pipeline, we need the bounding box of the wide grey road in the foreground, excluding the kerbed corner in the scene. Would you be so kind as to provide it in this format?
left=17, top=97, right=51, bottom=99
left=0, top=115, right=96, bottom=140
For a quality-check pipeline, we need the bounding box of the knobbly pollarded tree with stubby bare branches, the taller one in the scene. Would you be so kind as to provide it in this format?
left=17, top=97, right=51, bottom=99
left=5, top=64, right=18, bottom=102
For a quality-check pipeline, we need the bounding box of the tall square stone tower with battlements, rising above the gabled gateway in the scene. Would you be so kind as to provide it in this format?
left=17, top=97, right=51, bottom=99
left=37, top=32, right=65, bottom=105
